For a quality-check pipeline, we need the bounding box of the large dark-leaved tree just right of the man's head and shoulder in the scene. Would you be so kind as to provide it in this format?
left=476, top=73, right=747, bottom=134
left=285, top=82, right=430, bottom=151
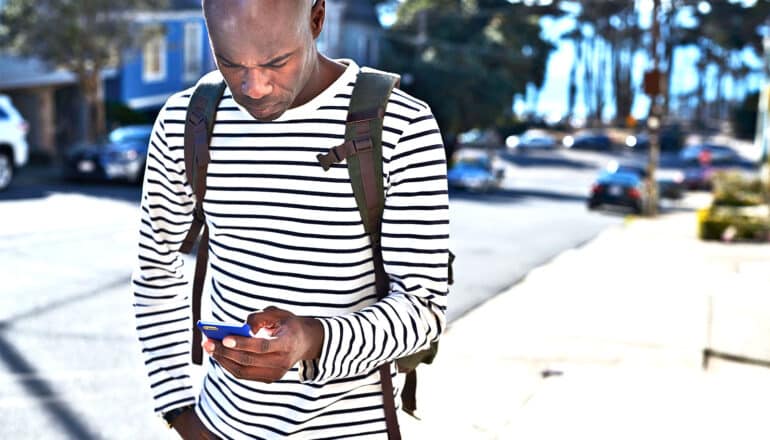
left=384, top=0, right=561, bottom=136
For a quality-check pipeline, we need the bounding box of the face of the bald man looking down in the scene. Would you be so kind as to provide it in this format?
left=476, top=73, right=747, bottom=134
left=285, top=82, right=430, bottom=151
left=204, top=0, right=316, bottom=121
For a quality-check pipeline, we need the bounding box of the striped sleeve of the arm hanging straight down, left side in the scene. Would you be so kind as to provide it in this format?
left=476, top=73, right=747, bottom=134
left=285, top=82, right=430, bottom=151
left=131, top=108, right=195, bottom=413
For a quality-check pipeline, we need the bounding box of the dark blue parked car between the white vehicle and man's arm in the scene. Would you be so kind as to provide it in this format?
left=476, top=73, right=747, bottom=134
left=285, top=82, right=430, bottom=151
left=64, top=125, right=152, bottom=183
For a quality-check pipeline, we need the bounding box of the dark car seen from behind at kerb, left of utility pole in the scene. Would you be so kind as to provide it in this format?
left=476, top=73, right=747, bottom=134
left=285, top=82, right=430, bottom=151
left=588, top=169, right=646, bottom=214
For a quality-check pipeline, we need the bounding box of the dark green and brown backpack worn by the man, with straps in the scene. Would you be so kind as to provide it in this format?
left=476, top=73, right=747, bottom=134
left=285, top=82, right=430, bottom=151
left=180, top=70, right=454, bottom=439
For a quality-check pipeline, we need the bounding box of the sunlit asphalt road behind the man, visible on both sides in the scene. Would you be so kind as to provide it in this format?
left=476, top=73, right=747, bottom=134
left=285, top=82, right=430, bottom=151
left=0, top=152, right=623, bottom=440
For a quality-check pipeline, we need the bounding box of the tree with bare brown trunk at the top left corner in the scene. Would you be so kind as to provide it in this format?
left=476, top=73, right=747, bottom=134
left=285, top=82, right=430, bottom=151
left=0, top=0, right=165, bottom=140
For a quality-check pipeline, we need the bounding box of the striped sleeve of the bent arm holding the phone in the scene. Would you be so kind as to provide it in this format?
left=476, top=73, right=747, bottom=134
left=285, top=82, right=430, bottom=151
left=300, top=105, right=449, bottom=383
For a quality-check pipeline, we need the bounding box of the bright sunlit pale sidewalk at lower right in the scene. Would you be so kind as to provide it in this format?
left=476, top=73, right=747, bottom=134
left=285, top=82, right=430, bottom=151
left=401, top=200, right=770, bottom=440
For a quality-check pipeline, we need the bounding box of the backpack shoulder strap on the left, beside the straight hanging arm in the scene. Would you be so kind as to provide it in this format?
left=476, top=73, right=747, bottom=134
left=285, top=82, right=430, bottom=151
left=179, top=71, right=225, bottom=365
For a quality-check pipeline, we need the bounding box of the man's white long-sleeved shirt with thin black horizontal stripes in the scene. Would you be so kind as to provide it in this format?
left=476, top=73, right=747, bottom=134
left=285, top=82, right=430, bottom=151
left=132, top=61, right=449, bottom=439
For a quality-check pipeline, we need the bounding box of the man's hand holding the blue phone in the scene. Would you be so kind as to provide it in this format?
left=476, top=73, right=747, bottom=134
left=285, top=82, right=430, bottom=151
left=203, top=307, right=323, bottom=383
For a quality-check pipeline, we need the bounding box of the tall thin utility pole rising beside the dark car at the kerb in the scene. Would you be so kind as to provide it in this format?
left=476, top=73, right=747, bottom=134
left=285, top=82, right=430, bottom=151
left=644, top=0, right=663, bottom=217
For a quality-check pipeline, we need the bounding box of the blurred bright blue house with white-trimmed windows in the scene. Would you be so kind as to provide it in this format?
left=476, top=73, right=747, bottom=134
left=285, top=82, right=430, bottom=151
left=106, top=2, right=216, bottom=115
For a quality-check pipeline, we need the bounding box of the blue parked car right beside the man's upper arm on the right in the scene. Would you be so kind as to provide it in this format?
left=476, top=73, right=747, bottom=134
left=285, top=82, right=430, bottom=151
left=447, top=150, right=505, bottom=192
